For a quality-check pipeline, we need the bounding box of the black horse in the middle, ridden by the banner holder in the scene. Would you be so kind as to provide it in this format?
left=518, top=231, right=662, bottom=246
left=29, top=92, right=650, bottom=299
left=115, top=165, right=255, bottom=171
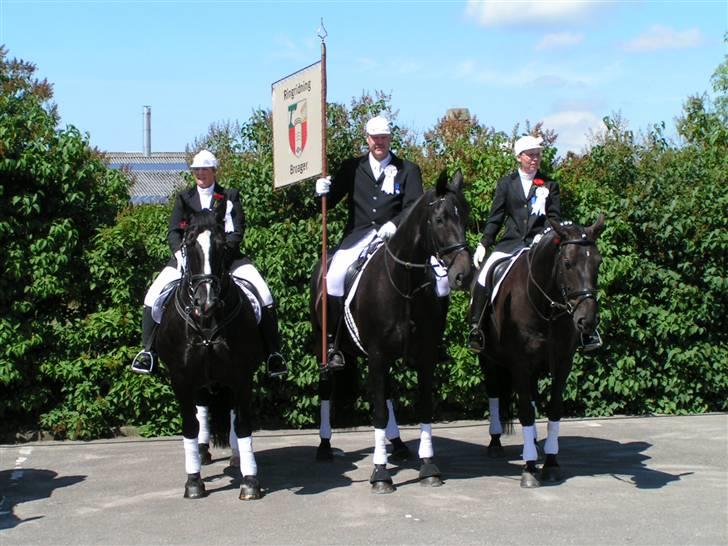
left=311, top=171, right=471, bottom=493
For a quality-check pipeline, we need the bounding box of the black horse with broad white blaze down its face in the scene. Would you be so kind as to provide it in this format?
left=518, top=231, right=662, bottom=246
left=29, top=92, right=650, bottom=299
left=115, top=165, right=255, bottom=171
left=157, top=203, right=263, bottom=500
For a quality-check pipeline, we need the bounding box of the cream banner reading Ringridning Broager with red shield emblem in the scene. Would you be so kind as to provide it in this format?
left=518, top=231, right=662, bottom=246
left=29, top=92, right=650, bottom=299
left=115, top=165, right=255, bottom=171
left=271, top=62, right=323, bottom=189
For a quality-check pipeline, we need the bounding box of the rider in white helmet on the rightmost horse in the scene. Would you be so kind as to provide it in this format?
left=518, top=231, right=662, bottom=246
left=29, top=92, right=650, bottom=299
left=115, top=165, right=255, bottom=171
left=468, top=135, right=600, bottom=353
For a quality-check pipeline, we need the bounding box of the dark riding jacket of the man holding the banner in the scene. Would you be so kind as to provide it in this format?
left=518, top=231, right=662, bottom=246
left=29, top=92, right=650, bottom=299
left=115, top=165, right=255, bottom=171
left=327, top=152, right=423, bottom=248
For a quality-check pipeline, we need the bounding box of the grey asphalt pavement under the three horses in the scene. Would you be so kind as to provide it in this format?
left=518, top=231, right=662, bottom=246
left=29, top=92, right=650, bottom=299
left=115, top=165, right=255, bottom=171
left=0, top=414, right=728, bottom=546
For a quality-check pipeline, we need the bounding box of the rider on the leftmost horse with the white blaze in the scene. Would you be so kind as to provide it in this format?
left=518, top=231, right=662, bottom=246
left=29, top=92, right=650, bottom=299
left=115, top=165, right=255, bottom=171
left=131, top=150, right=288, bottom=376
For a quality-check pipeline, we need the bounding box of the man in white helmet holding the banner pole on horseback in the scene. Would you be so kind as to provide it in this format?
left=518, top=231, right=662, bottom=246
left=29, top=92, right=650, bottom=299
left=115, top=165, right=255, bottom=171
left=316, top=116, right=450, bottom=370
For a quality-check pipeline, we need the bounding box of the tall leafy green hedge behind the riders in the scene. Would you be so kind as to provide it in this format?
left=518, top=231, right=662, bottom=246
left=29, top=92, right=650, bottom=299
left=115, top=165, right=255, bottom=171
left=0, top=45, right=728, bottom=439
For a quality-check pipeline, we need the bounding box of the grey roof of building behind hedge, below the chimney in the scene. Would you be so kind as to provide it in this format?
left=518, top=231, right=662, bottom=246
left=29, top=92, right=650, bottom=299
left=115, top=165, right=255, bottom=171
left=104, top=152, right=188, bottom=205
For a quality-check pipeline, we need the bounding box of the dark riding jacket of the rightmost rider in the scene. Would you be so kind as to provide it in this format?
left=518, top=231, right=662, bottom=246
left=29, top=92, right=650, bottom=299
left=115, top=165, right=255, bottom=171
left=481, top=171, right=561, bottom=253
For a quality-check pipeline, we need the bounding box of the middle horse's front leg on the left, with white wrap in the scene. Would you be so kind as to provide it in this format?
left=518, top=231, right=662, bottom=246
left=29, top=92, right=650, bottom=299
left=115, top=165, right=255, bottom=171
left=369, top=350, right=395, bottom=493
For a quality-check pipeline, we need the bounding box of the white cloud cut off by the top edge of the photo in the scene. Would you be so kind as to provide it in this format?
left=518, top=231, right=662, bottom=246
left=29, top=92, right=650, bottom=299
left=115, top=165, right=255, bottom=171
left=465, top=0, right=600, bottom=27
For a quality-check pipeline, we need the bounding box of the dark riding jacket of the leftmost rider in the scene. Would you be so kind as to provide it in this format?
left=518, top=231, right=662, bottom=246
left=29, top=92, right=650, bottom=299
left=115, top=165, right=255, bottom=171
left=167, top=181, right=245, bottom=267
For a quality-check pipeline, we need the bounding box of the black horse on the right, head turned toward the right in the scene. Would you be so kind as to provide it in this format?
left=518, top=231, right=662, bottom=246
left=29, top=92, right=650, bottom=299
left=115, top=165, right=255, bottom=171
left=480, top=215, right=604, bottom=487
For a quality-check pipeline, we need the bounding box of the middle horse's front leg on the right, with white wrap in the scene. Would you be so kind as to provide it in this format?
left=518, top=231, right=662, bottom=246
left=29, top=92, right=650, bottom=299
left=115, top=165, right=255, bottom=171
left=416, top=343, right=443, bottom=487
